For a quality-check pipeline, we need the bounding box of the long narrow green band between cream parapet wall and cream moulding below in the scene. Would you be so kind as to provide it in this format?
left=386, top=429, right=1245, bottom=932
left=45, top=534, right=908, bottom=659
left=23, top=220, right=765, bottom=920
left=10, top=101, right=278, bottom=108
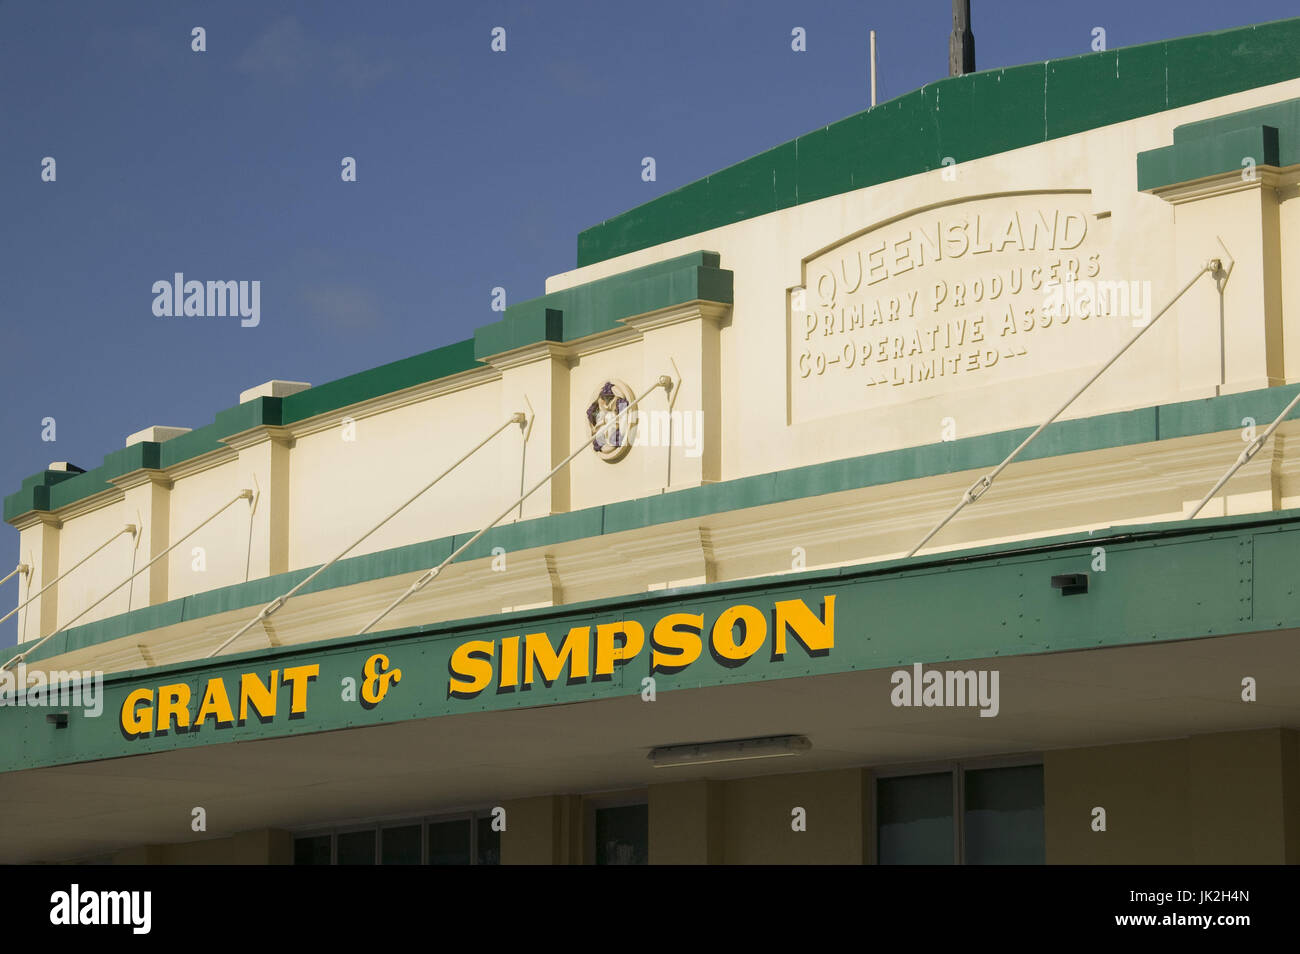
left=17, top=385, right=1300, bottom=662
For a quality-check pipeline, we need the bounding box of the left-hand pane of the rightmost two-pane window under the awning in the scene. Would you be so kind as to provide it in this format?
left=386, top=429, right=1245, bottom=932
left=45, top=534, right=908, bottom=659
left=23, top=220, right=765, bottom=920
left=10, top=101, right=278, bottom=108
left=876, top=772, right=956, bottom=864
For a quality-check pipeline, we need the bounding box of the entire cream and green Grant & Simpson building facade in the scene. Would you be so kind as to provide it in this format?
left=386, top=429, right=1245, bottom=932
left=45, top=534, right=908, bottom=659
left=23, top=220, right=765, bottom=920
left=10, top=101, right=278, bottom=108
left=0, top=19, right=1300, bottom=863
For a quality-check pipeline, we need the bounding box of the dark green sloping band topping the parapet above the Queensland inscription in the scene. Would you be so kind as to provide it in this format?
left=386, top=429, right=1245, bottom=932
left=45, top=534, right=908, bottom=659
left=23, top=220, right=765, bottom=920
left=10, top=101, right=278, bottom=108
left=577, top=18, right=1300, bottom=268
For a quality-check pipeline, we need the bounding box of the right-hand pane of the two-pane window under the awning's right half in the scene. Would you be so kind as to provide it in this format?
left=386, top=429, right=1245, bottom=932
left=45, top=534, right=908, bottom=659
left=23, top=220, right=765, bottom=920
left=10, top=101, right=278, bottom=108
left=965, top=766, right=1047, bottom=864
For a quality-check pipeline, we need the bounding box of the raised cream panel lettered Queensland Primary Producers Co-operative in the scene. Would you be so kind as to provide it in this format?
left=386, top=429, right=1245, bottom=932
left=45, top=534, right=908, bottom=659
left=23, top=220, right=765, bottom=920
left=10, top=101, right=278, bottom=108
left=789, top=194, right=1115, bottom=420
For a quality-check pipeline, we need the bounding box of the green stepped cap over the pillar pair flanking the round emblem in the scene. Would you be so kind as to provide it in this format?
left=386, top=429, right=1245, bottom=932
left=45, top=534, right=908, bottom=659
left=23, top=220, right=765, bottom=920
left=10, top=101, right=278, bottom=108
left=475, top=251, right=732, bottom=361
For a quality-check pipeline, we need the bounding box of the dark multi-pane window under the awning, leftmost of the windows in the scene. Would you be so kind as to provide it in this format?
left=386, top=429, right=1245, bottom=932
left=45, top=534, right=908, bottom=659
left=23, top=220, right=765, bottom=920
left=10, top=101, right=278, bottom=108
left=294, top=811, right=501, bottom=864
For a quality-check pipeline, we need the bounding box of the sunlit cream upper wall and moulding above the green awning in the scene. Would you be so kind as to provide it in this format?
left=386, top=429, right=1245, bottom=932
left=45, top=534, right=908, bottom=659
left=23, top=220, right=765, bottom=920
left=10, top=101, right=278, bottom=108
left=17, top=81, right=1300, bottom=658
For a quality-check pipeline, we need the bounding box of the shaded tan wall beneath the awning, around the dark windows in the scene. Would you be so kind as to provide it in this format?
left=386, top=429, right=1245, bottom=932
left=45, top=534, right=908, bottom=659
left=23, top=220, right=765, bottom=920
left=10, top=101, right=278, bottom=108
left=89, top=728, right=1300, bottom=864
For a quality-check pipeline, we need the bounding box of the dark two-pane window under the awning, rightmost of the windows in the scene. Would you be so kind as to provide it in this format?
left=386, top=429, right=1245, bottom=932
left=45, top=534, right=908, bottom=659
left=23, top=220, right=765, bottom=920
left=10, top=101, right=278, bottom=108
left=876, top=764, right=1045, bottom=864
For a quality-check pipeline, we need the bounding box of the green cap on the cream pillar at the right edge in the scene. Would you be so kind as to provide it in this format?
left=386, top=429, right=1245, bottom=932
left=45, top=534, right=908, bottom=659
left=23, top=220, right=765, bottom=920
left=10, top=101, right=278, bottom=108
left=1138, top=99, right=1300, bottom=192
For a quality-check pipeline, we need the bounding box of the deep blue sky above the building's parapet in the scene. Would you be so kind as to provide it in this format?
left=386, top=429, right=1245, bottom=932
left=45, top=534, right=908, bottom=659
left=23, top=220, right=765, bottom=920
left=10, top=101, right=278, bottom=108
left=0, top=0, right=1300, bottom=643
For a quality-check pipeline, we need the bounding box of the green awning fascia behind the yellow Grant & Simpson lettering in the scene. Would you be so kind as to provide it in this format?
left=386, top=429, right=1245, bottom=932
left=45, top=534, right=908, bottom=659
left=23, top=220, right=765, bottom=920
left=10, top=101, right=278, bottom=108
left=0, top=511, right=1300, bottom=772
